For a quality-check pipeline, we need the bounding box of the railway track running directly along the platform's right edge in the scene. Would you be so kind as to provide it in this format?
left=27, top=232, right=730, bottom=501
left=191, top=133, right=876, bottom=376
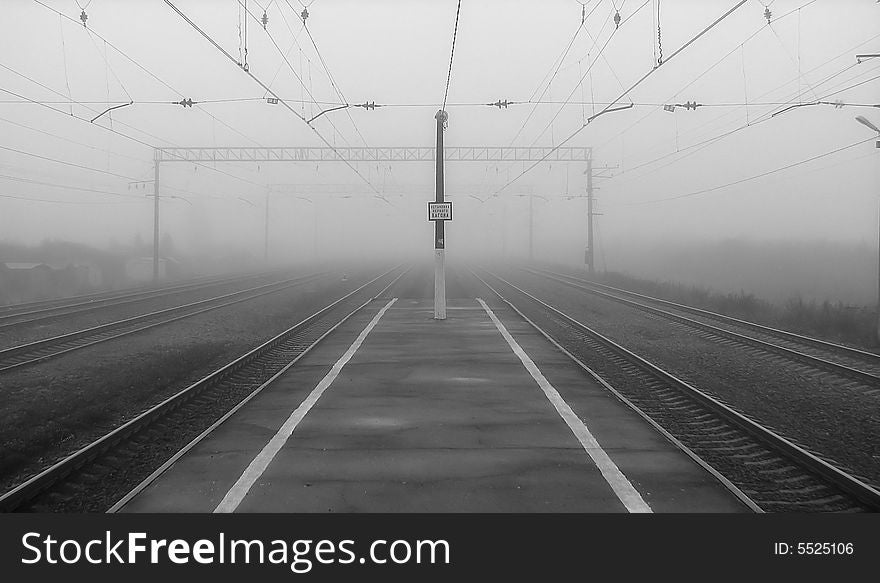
left=475, top=272, right=880, bottom=512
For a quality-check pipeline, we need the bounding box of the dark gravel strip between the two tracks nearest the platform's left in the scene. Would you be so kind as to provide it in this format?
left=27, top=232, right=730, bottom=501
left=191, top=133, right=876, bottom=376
left=0, top=267, right=379, bottom=491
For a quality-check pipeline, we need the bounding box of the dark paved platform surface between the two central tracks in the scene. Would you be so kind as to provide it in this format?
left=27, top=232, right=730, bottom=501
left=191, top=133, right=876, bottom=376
left=122, top=298, right=746, bottom=512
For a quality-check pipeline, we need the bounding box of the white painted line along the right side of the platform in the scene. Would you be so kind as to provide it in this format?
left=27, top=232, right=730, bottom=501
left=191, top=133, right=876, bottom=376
left=477, top=298, right=651, bottom=512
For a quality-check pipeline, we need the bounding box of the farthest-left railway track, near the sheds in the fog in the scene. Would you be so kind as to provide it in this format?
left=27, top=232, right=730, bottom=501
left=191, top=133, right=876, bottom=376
left=0, top=272, right=292, bottom=333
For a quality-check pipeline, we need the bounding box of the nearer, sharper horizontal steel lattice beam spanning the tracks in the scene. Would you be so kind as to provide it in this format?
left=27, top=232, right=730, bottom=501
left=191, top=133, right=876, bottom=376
left=155, top=146, right=592, bottom=162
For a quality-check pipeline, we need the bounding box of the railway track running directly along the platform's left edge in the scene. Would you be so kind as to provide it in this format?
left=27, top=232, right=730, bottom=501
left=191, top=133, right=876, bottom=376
left=0, top=266, right=407, bottom=512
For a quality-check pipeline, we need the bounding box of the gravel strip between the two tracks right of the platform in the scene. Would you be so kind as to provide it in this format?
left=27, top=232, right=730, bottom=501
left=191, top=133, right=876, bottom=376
left=504, top=272, right=880, bottom=484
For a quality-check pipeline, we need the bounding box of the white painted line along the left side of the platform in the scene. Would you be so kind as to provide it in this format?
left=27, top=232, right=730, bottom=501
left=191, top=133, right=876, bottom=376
left=214, top=298, right=397, bottom=513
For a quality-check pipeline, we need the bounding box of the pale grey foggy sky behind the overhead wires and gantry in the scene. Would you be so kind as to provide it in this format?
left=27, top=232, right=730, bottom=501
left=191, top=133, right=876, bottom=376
left=0, top=0, right=880, bottom=303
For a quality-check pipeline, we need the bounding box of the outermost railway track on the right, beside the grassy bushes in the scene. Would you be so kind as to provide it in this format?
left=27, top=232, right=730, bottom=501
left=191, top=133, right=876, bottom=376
left=525, top=269, right=880, bottom=396
